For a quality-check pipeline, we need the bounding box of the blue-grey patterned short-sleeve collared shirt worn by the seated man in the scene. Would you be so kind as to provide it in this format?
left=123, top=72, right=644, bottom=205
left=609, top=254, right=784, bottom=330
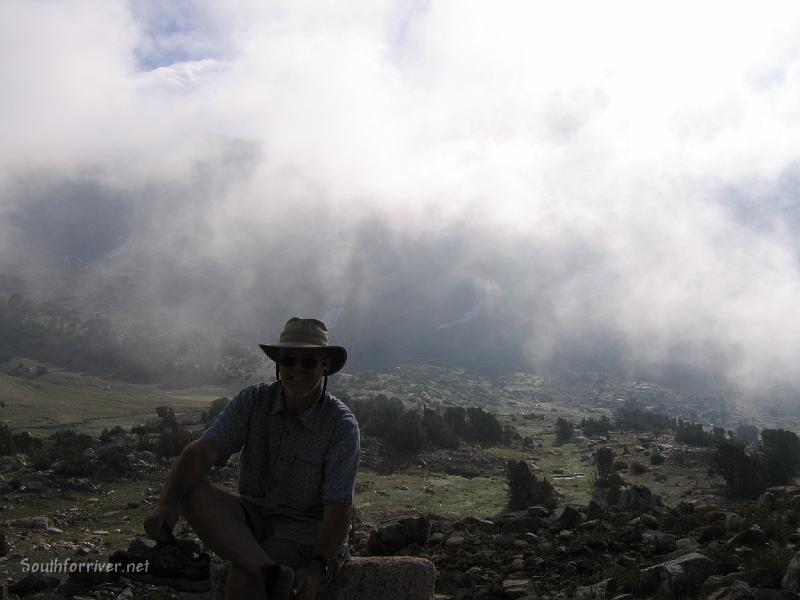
left=201, top=381, right=360, bottom=553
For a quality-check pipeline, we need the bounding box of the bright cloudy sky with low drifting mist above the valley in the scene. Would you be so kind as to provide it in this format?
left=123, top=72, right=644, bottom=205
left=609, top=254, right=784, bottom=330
left=0, top=0, right=800, bottom=390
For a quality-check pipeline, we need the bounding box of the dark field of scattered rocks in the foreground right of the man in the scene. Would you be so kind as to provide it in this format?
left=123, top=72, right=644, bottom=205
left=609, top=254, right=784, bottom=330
left=353, top=486, right=800, bottom=600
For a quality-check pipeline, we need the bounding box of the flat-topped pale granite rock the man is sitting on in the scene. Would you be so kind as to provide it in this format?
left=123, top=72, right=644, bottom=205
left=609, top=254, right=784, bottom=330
left=208, top=556, right=436, bottom=600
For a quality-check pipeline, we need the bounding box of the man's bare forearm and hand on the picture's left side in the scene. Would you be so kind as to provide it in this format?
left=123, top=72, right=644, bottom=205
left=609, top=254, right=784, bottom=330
left=144, top=440, right=217, bottom=539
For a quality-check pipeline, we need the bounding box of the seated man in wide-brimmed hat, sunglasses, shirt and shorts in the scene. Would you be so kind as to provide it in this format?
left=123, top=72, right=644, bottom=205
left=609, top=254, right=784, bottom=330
left=144, top=317, right=360, bottom=600
